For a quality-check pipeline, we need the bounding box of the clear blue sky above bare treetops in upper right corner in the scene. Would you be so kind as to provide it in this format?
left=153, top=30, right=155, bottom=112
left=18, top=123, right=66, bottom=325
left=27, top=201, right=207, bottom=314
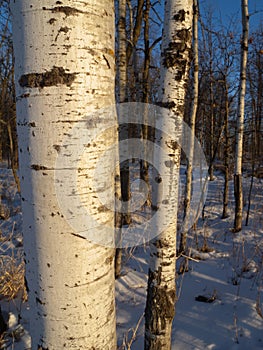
left=199, top=0, right=263, bottom=29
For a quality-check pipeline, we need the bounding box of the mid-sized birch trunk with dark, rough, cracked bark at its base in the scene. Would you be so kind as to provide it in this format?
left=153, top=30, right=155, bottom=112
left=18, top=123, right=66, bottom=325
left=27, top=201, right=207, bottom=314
left=144, top=0, right=193, bottom=350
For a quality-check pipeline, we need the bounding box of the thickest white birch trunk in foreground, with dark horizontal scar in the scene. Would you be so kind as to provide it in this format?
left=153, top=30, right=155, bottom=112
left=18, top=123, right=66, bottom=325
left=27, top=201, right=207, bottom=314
left=11, top=0, right=116, bottom=350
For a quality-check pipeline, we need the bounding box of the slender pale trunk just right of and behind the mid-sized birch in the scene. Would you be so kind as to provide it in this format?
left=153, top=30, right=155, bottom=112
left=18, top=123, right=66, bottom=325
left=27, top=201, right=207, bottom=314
left=179, top=0, right=199, bottom=253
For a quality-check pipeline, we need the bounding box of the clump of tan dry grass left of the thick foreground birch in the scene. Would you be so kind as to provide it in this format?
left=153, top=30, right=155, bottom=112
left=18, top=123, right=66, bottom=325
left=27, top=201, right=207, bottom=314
left=0, top=255, right=27, bottom=300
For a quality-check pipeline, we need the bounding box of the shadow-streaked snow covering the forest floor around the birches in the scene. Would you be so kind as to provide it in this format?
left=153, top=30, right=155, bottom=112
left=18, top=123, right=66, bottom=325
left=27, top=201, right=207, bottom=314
left=0, top=168, right=263, bottom=350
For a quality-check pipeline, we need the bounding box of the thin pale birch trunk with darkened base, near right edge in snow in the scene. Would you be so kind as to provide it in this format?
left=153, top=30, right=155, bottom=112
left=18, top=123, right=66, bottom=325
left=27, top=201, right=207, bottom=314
left=234, top=0, right=249, bottom=232
